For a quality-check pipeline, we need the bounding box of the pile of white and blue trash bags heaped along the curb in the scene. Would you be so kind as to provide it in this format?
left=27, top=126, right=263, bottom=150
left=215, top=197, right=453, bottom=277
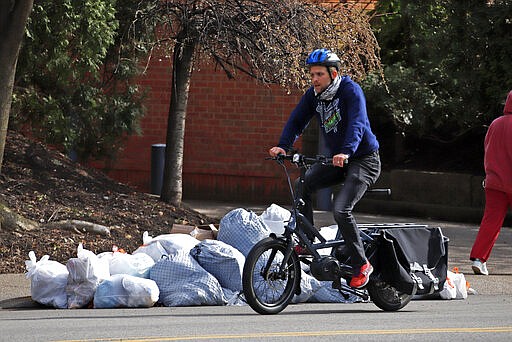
left=25, top=204, right=360, bottom=309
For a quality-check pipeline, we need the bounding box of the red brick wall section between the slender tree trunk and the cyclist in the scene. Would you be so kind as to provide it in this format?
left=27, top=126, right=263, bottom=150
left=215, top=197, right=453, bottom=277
left=183, top=60, right=306, bottom=201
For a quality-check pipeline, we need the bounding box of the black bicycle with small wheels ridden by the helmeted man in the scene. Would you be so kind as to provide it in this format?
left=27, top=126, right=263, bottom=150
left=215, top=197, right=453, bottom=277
left=242, top=154, right=414, bottom=314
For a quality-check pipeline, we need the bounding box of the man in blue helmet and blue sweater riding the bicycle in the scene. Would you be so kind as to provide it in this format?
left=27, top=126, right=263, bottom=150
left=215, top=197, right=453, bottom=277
left=269, top=49, right=381, bottom=288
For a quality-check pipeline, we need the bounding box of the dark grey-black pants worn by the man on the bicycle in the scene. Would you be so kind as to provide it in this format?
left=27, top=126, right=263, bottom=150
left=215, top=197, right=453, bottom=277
left=297, top=151, right=381, bottom=267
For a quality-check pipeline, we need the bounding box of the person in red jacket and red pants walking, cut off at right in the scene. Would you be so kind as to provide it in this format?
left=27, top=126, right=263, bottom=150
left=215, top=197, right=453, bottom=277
left=470, top=91, right=512, bottom=275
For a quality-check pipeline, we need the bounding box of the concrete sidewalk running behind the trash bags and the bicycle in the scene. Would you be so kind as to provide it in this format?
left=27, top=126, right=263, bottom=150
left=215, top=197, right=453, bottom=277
left=0, top=201, right=512, bottom=307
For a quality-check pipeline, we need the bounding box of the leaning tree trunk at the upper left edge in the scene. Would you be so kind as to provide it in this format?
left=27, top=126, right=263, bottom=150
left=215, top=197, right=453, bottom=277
left=0, top=0, right=33, bottom=173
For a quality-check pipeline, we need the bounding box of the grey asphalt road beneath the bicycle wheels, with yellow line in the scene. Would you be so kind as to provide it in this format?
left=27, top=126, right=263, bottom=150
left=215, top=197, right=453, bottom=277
left=0, top=295, right=512, bottom=342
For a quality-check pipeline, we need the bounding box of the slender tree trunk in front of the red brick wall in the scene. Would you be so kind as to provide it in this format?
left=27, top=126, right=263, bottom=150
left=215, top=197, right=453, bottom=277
left=160, top=33, right=196, bottom=206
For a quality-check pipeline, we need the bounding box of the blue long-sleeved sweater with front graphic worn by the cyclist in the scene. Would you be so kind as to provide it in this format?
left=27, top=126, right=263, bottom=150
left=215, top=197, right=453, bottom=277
left=278, top=76, right=379, bottom=158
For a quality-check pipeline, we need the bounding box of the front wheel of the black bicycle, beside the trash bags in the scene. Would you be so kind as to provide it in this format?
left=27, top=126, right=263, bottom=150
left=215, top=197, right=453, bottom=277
left=242, top=237, right=300, bottom=315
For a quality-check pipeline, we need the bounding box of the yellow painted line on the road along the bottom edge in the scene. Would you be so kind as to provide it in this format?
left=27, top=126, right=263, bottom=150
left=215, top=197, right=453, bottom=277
left=55, top=326, right=512, bottom=342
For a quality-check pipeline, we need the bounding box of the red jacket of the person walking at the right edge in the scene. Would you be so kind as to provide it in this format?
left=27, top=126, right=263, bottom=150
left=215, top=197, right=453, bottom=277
left=484, top=91, right=512, bottom=194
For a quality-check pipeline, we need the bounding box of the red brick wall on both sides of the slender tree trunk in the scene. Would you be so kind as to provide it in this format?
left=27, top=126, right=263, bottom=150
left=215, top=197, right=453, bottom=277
left=98, top=59, right=301, bottom=202
